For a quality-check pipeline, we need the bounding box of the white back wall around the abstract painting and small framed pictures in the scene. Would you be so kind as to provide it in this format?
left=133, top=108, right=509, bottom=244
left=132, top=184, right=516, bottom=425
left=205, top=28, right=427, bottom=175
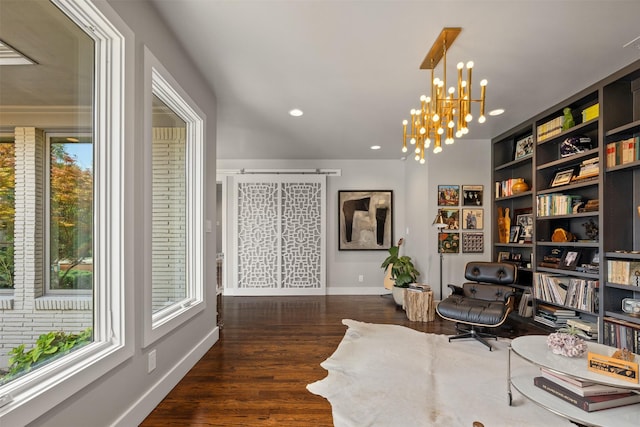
left=217, top=140, right=492, bottom=296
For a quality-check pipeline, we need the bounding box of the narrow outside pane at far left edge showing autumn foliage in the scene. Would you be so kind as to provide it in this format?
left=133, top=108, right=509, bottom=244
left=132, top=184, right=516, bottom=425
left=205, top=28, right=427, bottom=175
left=0, top=138, right=16, bottom=291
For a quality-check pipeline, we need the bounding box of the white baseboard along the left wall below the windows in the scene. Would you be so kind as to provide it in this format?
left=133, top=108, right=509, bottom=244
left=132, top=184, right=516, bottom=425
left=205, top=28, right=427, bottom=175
left=113, top=327, right=220, bottom=427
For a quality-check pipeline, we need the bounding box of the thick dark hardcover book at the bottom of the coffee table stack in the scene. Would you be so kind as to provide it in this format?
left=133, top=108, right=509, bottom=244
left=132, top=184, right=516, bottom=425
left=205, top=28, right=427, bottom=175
left=533, top=376, right=640, bottom=412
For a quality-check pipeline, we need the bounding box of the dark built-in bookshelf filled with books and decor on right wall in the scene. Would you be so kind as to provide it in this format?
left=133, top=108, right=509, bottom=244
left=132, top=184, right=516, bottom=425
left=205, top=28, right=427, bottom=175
left=492, top=57, right=640, bottom=344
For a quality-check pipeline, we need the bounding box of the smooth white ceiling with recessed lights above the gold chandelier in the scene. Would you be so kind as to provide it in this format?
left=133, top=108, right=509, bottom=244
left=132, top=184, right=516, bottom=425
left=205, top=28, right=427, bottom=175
left=153, top=0, right=640, bottom=159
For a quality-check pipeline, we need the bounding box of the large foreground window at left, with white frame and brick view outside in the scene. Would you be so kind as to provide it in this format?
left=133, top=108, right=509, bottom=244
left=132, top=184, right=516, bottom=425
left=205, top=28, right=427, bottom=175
left=0, top=0, right=133, bottom=425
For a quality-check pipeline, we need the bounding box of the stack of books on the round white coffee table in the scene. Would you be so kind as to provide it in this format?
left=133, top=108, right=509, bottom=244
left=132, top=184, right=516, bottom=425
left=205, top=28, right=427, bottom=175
left=533, top=368, right=640, bottom=412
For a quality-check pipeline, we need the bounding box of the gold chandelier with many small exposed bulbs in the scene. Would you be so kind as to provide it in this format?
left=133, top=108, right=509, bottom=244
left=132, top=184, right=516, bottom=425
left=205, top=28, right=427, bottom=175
left=402, top=27, right=487, bottom=163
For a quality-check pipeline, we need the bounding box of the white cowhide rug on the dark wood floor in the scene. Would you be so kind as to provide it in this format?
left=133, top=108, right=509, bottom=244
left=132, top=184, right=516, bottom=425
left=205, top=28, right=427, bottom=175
left=307, top=320, right=572, bottom=427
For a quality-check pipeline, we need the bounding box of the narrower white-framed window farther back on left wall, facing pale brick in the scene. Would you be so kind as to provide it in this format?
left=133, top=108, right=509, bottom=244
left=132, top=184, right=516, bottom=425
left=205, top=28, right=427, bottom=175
left=144, top=49, right=204, bottom=345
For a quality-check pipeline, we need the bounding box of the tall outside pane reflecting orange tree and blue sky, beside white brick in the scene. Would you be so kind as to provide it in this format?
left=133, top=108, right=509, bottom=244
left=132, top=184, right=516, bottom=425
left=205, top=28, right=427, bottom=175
left=49, top=137, right=93, bottom=291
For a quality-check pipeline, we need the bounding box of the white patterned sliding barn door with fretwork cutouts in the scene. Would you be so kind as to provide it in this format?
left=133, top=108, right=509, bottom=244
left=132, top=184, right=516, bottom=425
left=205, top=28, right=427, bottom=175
left=228, top=175, right=326, bottom=295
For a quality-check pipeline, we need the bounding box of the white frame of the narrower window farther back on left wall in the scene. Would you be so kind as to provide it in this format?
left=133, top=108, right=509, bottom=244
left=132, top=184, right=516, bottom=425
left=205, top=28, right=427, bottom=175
left=143, top=46, right=206, bottom=348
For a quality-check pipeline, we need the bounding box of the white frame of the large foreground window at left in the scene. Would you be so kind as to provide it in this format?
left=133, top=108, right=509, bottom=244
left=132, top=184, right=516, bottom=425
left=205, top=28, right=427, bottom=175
left=0, top=0, right=134, bottom=425
